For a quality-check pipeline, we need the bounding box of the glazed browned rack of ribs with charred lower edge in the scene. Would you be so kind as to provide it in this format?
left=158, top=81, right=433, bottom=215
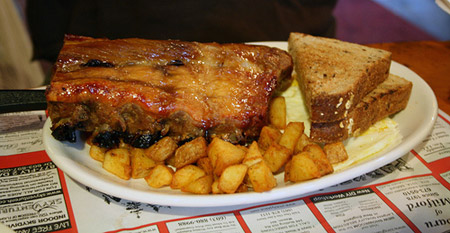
left=46, top=35, right=292, bottom=147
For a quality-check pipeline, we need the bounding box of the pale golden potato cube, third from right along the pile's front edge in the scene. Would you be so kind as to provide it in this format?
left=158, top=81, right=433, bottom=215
left=218, top=164, right=247, bottom=193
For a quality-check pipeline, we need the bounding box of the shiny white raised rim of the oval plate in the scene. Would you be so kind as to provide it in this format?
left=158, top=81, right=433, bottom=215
left=43, top=41, right=438, bottom=207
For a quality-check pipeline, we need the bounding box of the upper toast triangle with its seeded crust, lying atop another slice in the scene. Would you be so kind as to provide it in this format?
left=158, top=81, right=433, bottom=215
left=288, top=33, right=391, bottom=123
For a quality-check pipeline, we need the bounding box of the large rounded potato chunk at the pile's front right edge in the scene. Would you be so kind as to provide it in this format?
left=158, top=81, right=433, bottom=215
left=284, top=151, right=320, bottom=182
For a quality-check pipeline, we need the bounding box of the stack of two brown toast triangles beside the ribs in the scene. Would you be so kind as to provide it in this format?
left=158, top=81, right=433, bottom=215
left=288, top=33, right=412, bottom=143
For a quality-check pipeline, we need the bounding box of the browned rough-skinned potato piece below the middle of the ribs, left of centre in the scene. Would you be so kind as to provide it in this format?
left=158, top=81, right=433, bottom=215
left=174, top=137, right=207, bottom=168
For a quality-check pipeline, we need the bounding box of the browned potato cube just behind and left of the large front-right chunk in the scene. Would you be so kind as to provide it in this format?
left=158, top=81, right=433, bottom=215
left=263, top=143, right=292, bottom=173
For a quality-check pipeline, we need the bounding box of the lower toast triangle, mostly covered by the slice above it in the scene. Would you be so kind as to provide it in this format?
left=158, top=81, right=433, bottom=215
left=310, top=74, right=412, bottom=143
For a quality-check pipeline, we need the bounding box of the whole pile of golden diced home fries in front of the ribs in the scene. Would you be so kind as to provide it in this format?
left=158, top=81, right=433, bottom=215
left=89, top=95, right=348, bottom=194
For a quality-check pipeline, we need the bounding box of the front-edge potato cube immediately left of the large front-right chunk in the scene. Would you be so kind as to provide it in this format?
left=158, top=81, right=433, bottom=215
left=247, top=160, right=277, bottom=192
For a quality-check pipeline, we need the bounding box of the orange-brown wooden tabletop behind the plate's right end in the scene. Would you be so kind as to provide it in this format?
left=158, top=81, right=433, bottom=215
left=368, top=41, right=450, bottom=114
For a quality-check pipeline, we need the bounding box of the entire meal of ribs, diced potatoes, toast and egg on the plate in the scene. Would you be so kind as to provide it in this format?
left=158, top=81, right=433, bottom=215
left=46, top=33, right=412, bottom=194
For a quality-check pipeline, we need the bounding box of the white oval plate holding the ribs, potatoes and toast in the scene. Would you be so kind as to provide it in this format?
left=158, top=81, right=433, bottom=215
left=43, top=42, right=438, bottom=207
